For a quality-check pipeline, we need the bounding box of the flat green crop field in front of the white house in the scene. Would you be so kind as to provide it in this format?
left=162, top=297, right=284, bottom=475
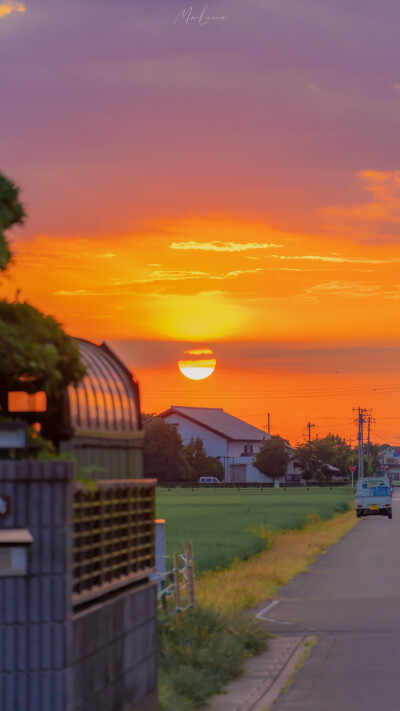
left=157, top=487, right=354, bottom=573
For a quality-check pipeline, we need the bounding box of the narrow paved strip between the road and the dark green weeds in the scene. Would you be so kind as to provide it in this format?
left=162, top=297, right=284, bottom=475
left=201, top=635, right=307, bottom=711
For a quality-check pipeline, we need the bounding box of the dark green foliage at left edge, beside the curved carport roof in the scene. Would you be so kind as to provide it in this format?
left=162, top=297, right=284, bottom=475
left=0, top=173, right=86, bottom=395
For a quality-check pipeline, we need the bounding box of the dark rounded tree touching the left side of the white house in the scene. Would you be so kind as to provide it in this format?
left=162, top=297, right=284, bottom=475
left=143, top=418, right=192, bottom=481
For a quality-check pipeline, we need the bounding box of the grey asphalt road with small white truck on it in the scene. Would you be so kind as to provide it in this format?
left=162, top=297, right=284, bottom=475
left=258, top=489, right=400, bottom=711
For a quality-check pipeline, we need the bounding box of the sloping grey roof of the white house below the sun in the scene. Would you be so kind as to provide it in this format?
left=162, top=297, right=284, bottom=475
left=158, top=405, right=270, bottom=442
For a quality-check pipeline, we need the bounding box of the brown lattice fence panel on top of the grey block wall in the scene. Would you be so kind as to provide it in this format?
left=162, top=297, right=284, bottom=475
left=73, top=479, right=156, bottom=606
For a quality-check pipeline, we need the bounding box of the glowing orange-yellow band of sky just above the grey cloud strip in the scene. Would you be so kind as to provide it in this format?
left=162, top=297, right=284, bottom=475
left=3, top=173, right=400, bottom=342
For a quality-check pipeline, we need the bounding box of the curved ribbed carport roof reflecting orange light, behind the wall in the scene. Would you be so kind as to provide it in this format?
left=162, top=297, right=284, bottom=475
left=68, top=338, right=140, bottom=434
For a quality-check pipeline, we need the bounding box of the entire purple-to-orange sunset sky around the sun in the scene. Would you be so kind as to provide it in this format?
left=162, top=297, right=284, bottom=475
left=0, top=0, right=400, bottom=444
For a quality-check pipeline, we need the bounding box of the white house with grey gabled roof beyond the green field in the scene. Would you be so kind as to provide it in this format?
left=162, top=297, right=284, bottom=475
left=158, top=405, right=301, bottom=483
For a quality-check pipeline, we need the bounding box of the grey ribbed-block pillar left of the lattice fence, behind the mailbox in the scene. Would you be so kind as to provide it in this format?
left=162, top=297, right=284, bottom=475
left=0, top=460, right=73, bottom=711
